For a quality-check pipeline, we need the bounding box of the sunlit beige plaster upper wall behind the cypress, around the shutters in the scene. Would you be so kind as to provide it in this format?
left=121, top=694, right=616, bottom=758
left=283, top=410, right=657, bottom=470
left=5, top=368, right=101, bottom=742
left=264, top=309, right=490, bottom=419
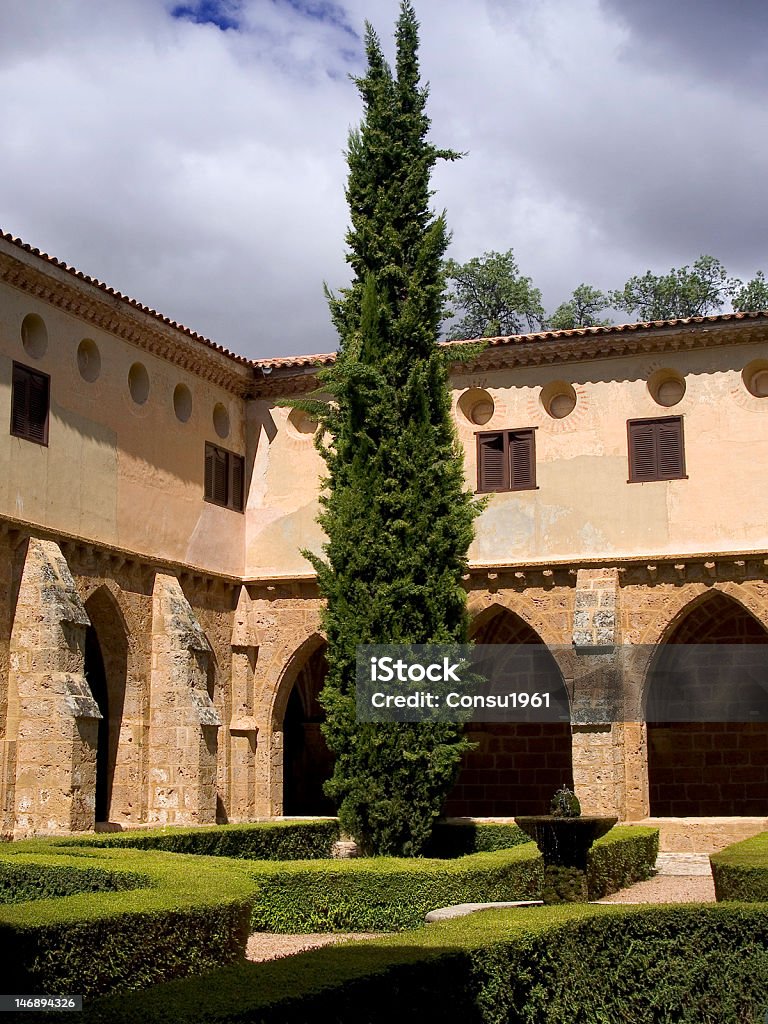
left=246, top=344, right=768, bottom=577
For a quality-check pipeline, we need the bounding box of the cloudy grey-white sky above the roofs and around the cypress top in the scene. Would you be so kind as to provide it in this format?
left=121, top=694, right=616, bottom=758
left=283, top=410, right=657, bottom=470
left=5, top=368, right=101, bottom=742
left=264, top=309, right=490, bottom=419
left=0, top=0, right=768, bottom=356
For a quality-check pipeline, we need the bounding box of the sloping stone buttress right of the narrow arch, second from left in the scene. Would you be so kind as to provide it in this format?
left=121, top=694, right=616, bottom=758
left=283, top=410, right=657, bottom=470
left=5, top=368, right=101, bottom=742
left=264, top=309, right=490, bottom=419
left=147, top=573, right=221, bottom=825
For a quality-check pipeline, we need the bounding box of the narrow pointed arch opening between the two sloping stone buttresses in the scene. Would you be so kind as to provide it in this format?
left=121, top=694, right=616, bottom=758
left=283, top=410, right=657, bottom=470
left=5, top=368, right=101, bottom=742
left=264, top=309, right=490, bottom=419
left=84, top=587, right=130, bottom=822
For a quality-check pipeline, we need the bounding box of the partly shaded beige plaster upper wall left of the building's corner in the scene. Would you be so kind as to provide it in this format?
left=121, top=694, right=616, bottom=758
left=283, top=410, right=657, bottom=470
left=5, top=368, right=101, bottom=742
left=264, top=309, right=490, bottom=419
left=0, top=283, right=246, bottom=574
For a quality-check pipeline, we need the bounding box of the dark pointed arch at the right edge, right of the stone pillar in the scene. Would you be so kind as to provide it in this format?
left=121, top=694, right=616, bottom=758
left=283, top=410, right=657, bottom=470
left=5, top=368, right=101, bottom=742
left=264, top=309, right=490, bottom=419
left=646, top=591, right=768, bottom=817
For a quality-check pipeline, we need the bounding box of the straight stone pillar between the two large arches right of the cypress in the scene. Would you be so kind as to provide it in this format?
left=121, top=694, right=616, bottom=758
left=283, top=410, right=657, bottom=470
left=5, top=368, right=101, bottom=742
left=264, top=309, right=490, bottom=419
left=571, top=568, right=627, bottom=818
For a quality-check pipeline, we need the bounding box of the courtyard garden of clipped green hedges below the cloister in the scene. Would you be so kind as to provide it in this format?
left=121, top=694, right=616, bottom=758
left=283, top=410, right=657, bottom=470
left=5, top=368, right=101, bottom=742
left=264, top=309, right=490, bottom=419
left=0, top=820, right=768, bottom=1024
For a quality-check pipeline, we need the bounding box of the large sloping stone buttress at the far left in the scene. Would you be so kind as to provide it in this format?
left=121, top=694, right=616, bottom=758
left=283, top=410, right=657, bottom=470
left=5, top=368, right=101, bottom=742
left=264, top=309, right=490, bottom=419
left=7, top=538, right=101, bottom=836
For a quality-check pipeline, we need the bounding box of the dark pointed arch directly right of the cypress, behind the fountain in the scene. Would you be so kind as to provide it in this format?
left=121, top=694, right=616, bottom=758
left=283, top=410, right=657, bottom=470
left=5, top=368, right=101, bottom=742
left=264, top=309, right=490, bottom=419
left=443, top=608, right=573, bottom=817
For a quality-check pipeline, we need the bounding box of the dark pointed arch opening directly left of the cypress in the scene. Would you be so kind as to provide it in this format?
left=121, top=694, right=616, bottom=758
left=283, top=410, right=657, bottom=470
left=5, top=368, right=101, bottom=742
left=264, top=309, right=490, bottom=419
left=283, top=643, right=336, bottom=814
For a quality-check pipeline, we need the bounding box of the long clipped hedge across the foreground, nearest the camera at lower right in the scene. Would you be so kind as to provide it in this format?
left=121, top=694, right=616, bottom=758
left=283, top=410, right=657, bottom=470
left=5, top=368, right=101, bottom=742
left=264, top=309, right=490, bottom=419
left=83, top=905, right=768, bottom=1024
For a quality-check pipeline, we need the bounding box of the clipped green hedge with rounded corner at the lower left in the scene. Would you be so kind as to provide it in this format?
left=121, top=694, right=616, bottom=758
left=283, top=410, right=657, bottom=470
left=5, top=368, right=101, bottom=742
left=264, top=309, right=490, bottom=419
left=0, top=842, right=253, bottom=995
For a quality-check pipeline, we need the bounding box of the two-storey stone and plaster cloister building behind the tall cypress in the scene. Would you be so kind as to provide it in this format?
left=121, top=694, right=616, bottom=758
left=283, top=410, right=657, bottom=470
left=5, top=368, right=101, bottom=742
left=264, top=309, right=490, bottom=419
left=0, top=228, right=768, bottom=837
